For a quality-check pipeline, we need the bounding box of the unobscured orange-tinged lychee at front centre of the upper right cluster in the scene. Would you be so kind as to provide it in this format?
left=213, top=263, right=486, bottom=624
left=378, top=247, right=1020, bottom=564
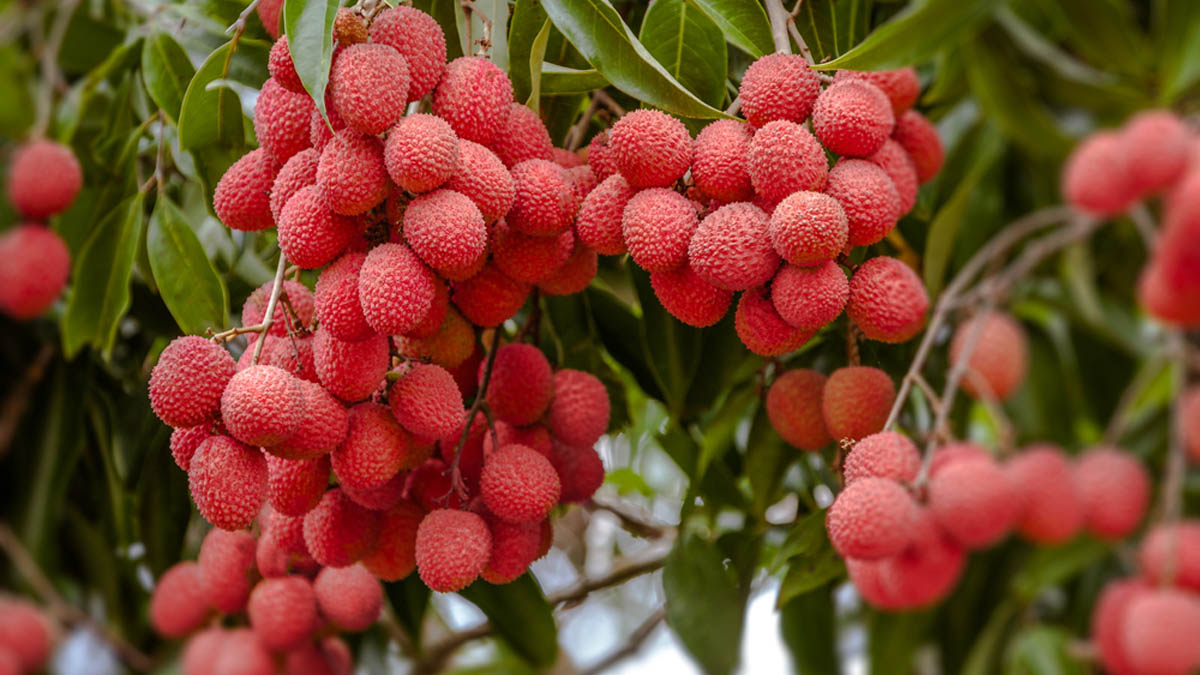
left=769, top=190, right=850, bottom=267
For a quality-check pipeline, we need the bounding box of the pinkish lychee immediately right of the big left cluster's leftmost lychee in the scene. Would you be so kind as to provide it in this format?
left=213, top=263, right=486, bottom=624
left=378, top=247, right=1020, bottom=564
left=221, top=365, right=304, bottom=446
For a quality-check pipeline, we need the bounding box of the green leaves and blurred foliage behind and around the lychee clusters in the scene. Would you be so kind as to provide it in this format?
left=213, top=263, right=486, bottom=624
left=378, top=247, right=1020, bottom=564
left=0, top=0, right=1200, bottom=674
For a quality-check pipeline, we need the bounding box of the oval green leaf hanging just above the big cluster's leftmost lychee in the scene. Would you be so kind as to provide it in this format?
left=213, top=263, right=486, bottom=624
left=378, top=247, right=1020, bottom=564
left=146, top=197, right=229, bottom=335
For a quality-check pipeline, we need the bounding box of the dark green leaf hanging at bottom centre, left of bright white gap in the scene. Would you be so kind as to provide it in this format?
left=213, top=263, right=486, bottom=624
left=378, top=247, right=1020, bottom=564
left=662, top=534, right=744, bottom=675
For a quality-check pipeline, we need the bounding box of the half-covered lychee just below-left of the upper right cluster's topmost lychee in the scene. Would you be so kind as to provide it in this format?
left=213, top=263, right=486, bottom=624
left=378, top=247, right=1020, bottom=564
left=691, top=120, right=754, bottom=202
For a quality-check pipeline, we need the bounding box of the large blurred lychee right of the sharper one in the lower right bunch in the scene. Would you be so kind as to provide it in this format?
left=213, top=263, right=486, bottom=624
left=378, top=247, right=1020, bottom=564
left=929, top=459, right=1021, bottom=549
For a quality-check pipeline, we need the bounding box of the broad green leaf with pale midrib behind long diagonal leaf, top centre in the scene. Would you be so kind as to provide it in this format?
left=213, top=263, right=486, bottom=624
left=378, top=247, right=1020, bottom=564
left=637, top=0, right=728, bottom=106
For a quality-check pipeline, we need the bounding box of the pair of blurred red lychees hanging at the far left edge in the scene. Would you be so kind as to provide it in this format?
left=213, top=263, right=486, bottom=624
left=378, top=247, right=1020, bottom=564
left=0, top=138, right=83, bottom=321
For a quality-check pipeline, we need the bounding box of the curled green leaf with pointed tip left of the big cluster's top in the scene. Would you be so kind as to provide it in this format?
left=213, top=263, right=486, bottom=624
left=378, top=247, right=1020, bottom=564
left=179, top=42, right=245, bottom=150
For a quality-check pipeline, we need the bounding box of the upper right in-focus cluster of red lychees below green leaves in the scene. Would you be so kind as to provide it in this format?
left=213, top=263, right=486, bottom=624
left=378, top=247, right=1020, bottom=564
left=576, top=54, right=942, bottom=356
